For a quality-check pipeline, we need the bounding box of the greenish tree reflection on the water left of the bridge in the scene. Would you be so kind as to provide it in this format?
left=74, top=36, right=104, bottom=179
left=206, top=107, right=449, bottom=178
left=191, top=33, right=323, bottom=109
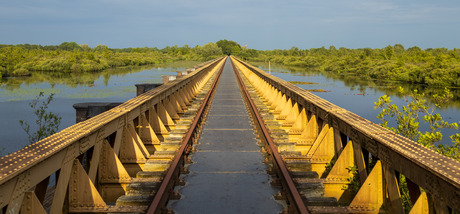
left=0, top=61, right=200, bottom=90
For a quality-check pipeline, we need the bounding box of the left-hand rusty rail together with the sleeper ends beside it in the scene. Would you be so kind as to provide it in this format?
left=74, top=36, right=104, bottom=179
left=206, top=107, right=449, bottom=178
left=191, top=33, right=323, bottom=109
left=116, top=58, right=225, bottom=213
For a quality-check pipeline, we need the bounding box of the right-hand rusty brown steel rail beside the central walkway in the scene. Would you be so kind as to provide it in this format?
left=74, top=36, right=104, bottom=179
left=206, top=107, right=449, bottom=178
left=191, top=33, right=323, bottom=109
left=232, top=58, right=309, bottom=214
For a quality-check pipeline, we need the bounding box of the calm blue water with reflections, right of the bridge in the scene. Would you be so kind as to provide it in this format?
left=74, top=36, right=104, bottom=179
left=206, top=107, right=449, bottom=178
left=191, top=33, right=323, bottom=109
left=251, top=63, right=460, bottom=145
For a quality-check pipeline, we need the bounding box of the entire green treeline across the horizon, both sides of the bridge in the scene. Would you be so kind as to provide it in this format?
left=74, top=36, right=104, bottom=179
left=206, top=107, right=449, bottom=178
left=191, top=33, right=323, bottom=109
left=0, top=40, right=460, bottom=87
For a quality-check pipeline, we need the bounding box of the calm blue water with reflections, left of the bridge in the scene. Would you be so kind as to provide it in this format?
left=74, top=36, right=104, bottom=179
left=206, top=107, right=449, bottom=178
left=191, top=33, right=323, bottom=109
left=0, top=62, right=199, bottom=155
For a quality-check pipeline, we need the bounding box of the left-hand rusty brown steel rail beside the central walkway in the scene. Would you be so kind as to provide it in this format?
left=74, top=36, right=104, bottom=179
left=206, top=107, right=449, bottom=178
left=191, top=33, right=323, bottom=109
left=147, top=57, right=228, bottom=214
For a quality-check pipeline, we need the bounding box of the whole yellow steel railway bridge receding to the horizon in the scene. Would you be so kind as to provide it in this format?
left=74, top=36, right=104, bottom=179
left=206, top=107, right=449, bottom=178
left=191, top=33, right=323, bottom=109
left=0, top=57, right=460, bottom=213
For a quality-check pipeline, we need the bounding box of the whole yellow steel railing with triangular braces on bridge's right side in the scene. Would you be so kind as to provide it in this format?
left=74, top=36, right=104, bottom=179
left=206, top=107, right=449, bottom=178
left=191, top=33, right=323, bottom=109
left=233, top=58, right=460, bottom=213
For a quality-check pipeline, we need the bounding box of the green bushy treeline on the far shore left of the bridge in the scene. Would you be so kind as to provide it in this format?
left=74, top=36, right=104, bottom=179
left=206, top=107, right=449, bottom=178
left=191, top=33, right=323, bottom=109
left=0, top=42, right=222, bottom=77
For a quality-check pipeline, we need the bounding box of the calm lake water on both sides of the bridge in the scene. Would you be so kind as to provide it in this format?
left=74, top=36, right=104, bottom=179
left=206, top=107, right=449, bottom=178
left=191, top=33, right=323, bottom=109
left=0, top=62, right=460, bottom=155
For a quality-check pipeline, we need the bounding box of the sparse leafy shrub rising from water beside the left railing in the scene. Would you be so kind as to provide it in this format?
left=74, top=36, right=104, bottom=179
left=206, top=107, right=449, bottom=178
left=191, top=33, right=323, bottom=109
left=19, top=92, right=61, bottom=144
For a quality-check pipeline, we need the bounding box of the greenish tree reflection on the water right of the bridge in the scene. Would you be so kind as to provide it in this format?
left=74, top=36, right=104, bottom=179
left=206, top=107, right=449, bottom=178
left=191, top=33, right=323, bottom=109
left=250, top=62, right=460, bottom=108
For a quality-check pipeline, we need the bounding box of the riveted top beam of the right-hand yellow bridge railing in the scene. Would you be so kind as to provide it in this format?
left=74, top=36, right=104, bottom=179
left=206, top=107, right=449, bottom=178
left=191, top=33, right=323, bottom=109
left=236, top=56, right=460, bottom=210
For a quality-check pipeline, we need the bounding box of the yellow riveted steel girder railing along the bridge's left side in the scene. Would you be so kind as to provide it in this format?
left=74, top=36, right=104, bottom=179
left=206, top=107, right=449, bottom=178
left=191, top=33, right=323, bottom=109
left=0, top=58, right=223, bottom=213
